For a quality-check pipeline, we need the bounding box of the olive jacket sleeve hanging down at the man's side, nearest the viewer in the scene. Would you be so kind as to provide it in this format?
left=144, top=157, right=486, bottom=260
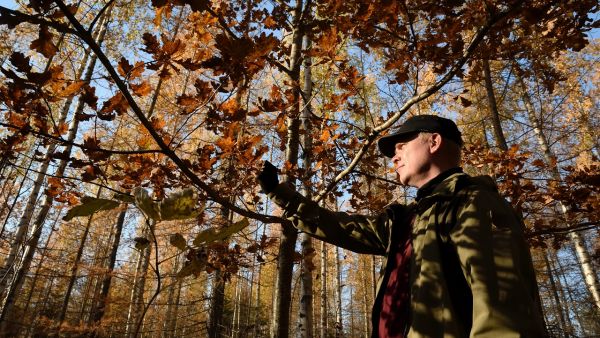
left=450, top=190, right=544, bottom=338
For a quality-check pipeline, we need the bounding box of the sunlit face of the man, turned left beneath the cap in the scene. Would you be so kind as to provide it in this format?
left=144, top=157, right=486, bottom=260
left=392, top=134, right=431, bottom=188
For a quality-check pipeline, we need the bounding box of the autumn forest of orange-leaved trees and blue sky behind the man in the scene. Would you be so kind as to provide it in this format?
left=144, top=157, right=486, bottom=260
left=0, top=0, right=600, bottom=337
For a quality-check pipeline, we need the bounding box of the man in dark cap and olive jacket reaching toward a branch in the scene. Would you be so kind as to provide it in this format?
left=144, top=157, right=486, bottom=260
left=258, top=115, right=546, bottom=338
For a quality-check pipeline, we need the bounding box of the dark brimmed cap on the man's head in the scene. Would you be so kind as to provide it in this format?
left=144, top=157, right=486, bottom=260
left=377, top=115, right=463, bottom=157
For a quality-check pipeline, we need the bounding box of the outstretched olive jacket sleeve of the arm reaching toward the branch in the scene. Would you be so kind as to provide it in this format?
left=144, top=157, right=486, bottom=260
left=269, top=183, right=393, bottom=255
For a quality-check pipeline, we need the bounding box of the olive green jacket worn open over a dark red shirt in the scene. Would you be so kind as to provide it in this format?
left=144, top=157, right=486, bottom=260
left=270, top=173, right=546, bottom=338
